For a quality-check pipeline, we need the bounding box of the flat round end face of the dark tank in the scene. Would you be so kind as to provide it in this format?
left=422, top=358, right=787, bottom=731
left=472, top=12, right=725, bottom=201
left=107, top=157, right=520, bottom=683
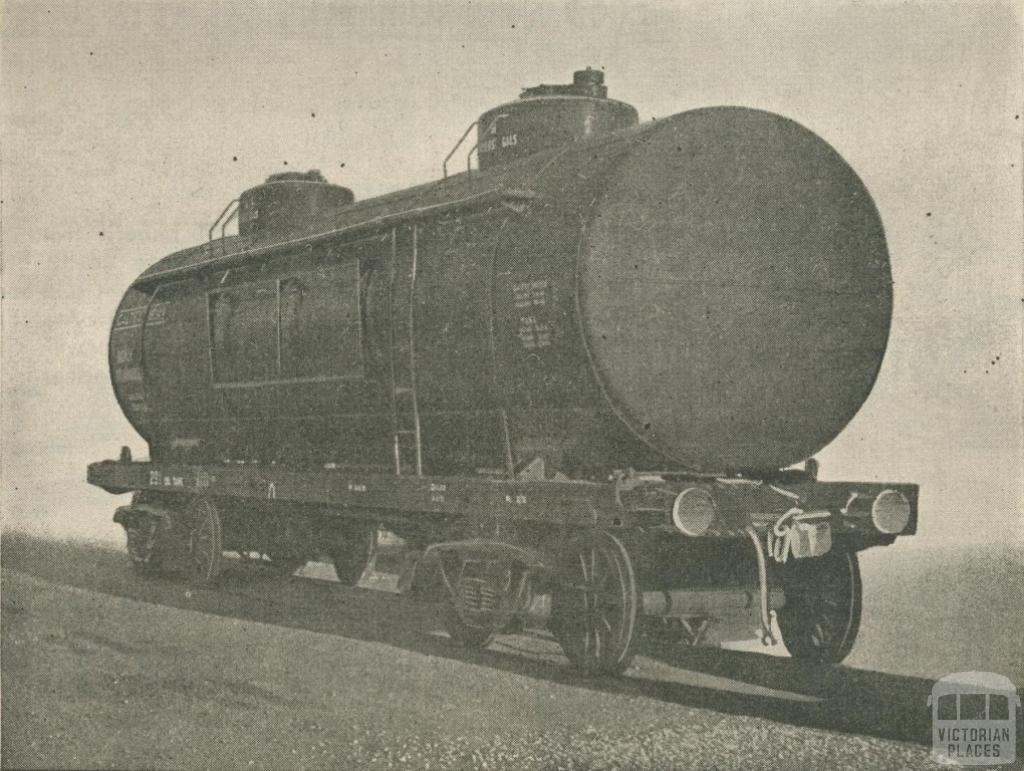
left=578, top=109, right=892, bottom=470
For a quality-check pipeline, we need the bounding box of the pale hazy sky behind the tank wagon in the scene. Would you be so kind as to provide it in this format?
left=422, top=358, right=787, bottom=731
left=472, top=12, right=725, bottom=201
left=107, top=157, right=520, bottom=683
left=0, top=2, right=1024, bottom=541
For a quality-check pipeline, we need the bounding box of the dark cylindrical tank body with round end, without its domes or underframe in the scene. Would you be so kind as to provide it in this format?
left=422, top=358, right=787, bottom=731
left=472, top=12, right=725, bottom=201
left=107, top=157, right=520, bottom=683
left=111, top=70, right=892, bottom=477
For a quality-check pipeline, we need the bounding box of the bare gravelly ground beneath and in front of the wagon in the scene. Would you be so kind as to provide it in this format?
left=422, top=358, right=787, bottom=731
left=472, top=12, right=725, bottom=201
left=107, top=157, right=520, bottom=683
left=2, top=533, right=1021, bottom=769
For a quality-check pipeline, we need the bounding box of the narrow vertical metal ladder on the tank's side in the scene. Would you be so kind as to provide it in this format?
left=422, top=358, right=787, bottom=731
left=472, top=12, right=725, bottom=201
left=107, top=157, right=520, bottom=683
left=389, top=224, right=423, bottom=476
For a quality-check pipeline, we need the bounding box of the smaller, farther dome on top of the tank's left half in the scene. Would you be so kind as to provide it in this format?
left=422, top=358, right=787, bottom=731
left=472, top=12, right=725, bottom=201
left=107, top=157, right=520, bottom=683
left=239, top=169, right=355, bottom=235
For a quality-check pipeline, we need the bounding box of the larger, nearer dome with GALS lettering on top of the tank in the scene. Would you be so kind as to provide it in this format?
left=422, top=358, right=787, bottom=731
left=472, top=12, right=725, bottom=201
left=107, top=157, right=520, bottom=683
left=477, top=67, right=639, bottom=169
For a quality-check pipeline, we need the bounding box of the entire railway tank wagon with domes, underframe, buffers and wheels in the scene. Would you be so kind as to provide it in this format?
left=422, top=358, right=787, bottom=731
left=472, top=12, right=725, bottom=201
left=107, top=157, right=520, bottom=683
left=89, top=69, right=916, bottom=672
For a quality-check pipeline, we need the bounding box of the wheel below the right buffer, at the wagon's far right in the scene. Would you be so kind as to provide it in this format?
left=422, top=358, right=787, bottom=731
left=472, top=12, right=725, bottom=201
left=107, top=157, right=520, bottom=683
left=778, top=549, right=861, bottom=663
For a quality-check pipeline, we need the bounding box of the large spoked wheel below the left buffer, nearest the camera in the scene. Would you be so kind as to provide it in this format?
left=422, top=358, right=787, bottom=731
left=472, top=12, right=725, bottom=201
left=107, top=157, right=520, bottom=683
left=551, top=532, right=640, bottom=675
